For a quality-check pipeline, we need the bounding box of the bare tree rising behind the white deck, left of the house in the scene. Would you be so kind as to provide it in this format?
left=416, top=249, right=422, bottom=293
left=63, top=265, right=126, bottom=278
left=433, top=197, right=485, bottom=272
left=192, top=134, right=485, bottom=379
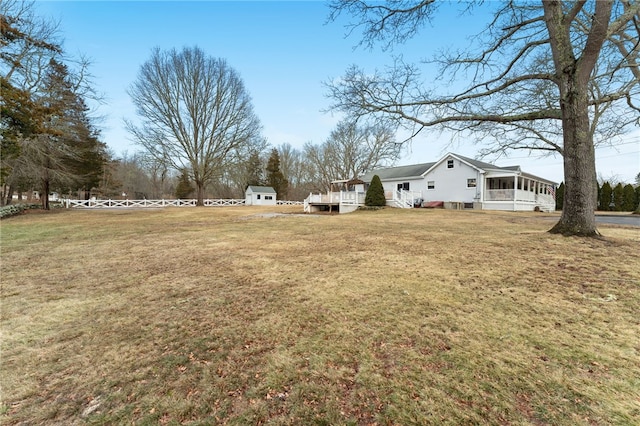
left=305, top=121, right=401, bottom=189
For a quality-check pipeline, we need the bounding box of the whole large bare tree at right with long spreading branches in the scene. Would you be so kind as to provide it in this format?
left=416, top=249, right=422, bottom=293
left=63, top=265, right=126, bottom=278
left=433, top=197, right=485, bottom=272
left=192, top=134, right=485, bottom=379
left=330, top=0, right=640, bottom=236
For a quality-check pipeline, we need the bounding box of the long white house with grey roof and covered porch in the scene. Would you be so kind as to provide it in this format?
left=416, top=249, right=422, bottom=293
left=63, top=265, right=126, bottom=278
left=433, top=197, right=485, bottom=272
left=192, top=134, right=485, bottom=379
left=305, top=153, right=556, bottom=211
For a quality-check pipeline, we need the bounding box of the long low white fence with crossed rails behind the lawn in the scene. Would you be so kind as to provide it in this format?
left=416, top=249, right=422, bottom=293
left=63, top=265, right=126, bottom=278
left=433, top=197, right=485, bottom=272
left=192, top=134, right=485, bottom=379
left=62, top=198, right=302, bottom=209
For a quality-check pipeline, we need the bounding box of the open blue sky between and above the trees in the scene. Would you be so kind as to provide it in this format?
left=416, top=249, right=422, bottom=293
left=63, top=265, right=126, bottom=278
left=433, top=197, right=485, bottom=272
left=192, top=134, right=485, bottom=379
left=37, top=1, right=640, bottom=182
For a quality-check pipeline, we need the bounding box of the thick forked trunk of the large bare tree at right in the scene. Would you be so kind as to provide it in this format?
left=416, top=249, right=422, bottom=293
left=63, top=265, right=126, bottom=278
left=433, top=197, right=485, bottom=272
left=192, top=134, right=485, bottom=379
left=543, top=0, right=613, bottom=237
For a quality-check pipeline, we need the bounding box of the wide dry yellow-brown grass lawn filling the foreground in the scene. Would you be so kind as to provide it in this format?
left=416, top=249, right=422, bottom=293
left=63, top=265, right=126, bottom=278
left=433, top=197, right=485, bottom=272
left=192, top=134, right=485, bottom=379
left=0, top=207, right=640, bottom=425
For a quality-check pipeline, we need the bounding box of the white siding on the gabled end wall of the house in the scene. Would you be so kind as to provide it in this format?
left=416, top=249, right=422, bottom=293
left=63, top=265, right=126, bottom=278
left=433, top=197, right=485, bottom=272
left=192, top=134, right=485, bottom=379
left=423, top=157, right=483, bottom=203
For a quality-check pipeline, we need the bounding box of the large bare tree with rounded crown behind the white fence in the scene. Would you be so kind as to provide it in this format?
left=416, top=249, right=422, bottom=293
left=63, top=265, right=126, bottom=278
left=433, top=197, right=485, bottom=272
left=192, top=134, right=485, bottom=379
left=127, top=47, right=260, bottom=206
